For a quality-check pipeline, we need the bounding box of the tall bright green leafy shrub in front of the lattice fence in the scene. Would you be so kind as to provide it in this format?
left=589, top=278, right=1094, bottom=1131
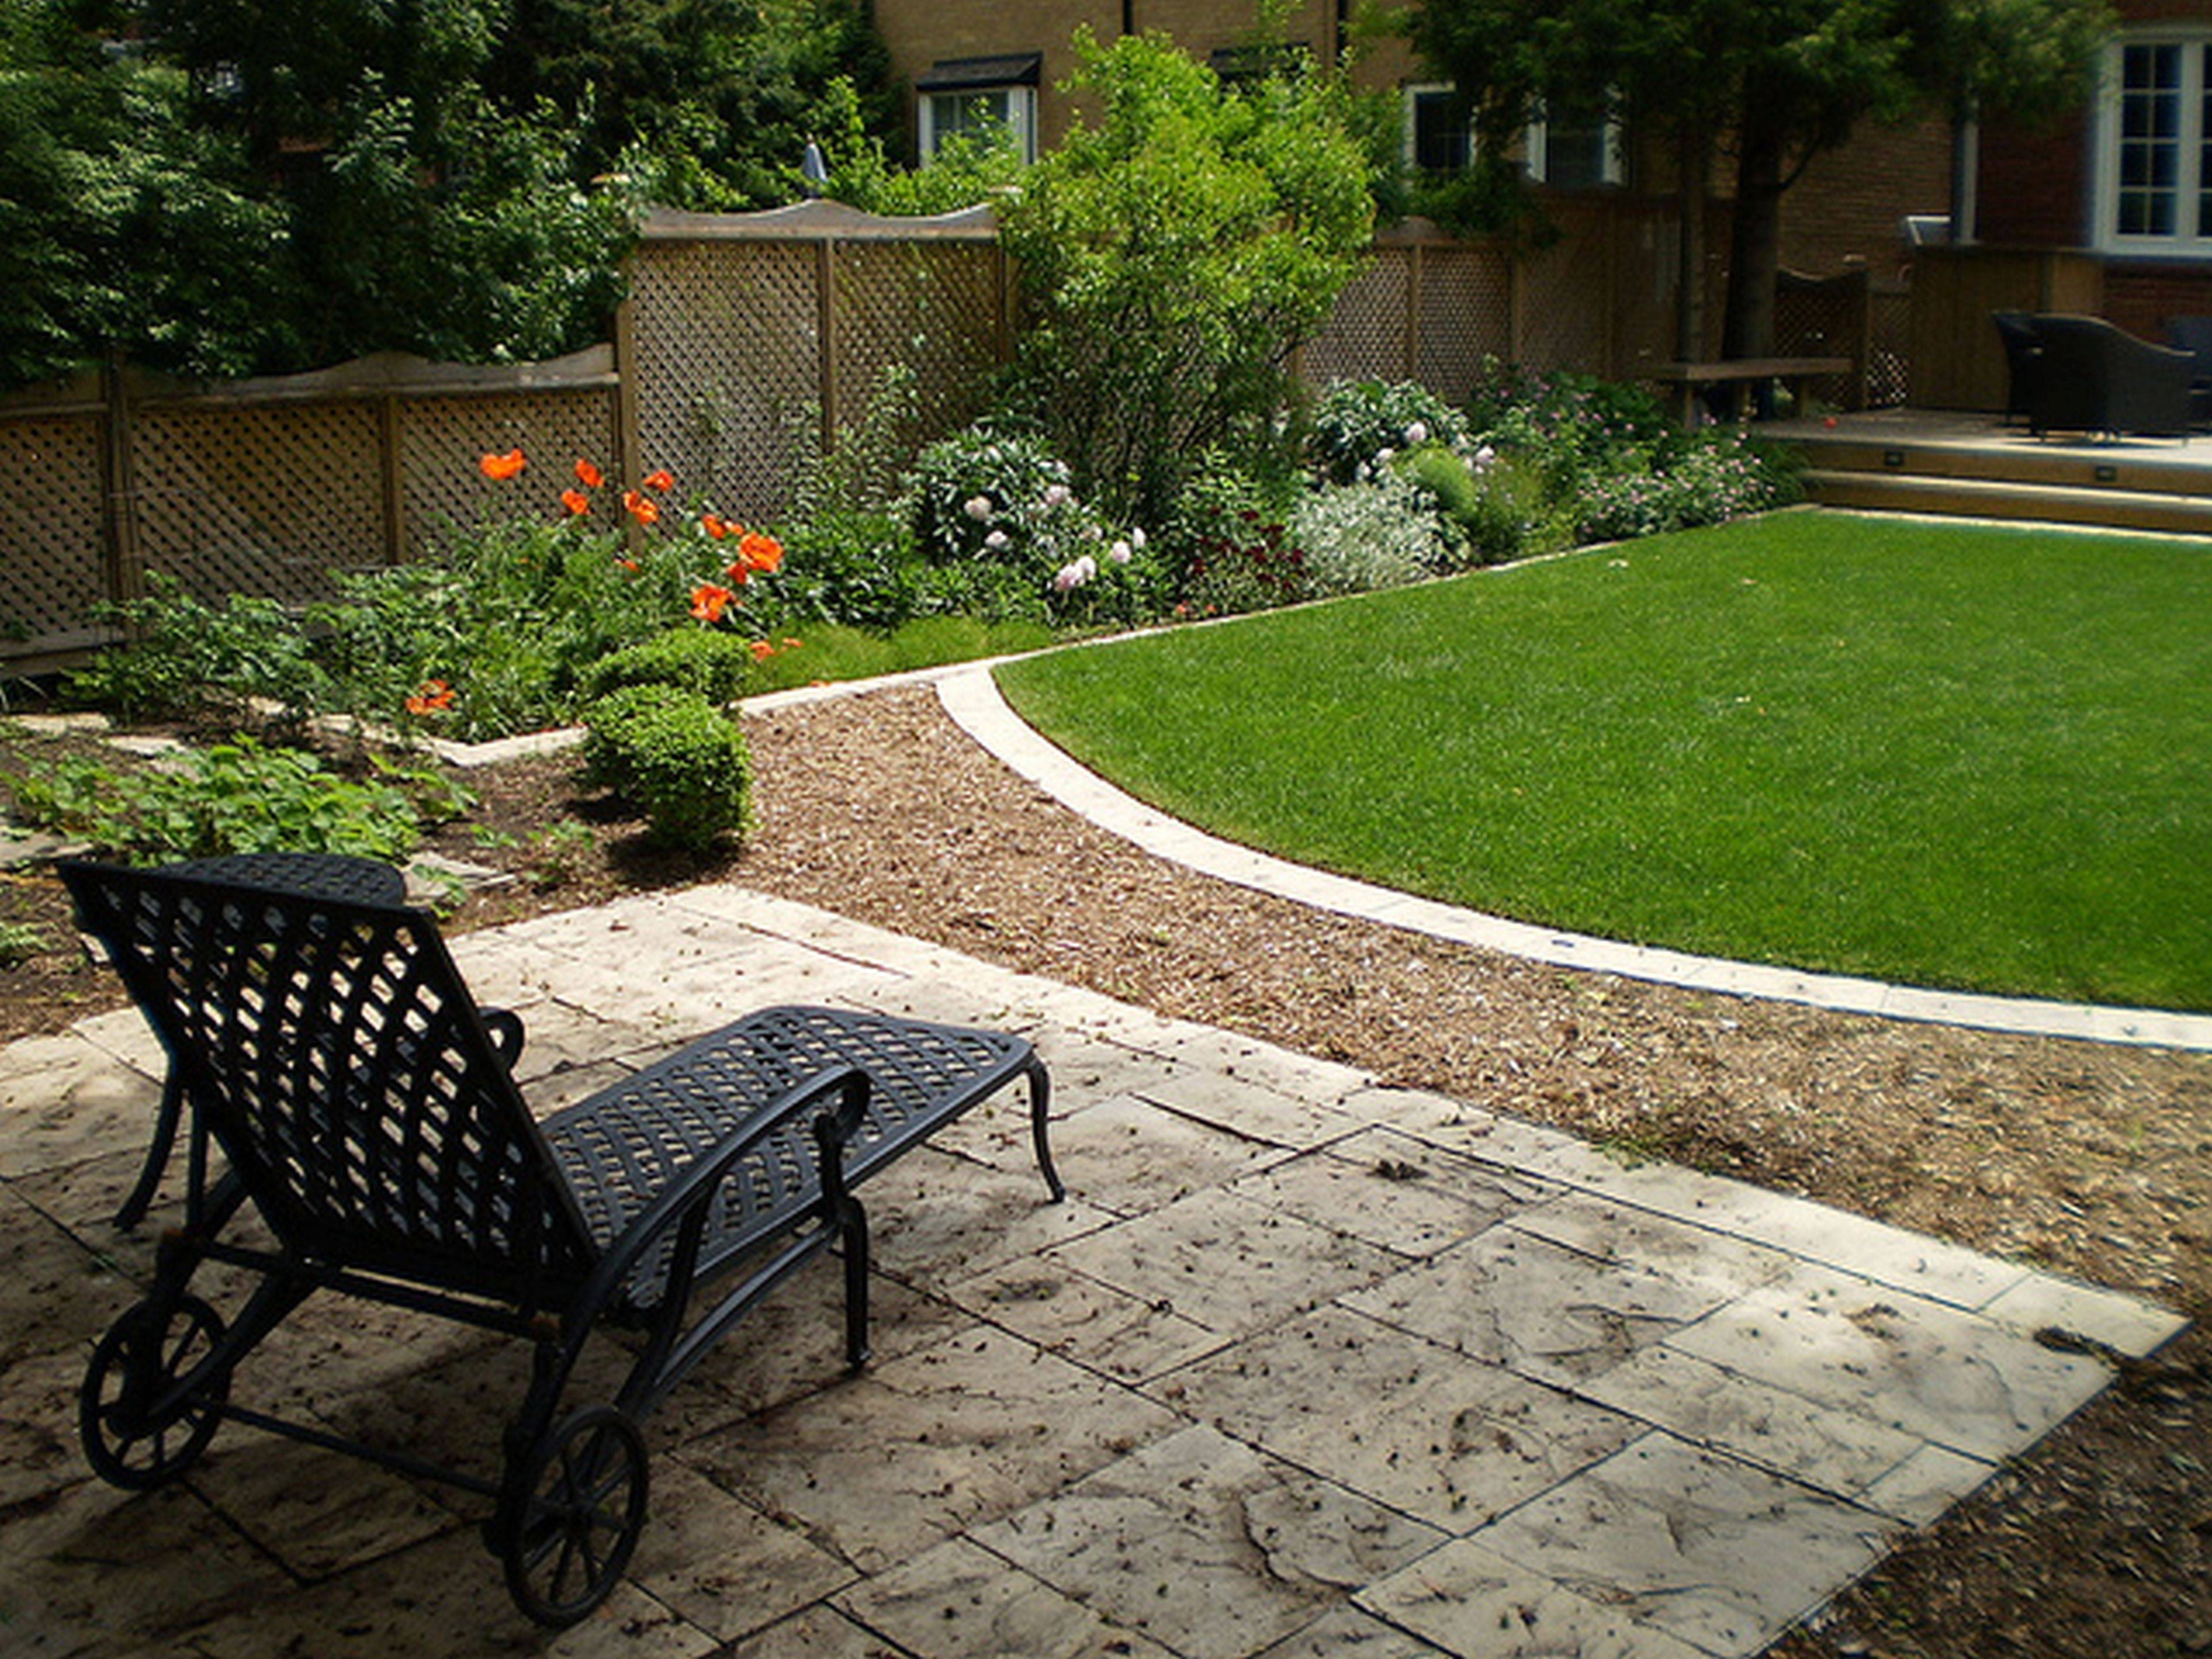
left=1002, top=35, right=1374, bottom=524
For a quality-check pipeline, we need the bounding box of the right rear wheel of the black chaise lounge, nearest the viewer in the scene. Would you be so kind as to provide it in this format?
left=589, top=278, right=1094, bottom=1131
left=498, top=1405, right=646, bottom=1626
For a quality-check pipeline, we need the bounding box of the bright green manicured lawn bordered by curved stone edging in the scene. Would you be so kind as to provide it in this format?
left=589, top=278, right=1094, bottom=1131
left=1000, top=513, right=2212, bottom=1009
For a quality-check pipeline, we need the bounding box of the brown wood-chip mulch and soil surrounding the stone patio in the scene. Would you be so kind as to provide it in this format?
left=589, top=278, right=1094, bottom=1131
left=0, top=690, right=2212, bottom=1659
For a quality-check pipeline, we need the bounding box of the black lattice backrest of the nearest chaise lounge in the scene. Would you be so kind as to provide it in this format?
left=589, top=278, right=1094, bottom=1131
left=62, top=863, right=593, bottom=1307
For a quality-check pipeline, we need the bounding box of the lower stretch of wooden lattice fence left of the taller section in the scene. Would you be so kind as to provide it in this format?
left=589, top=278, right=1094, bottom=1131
left=0, top=345, right=619, bottom=668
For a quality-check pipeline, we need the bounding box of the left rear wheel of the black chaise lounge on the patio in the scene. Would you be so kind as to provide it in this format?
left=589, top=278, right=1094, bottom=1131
left=77, top=1296, right=230, bottom=1491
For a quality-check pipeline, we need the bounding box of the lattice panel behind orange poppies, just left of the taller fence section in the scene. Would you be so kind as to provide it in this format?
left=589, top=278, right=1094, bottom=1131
left=398, top=389, right=619, bottom=557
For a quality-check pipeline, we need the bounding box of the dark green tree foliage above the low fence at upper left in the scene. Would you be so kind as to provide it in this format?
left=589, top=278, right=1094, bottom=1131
left=0, top=0, right=889, bottom=385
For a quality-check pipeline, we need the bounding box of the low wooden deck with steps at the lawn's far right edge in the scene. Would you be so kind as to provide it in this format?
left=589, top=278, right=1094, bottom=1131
left=1759, top=409, right=2212, bottom=535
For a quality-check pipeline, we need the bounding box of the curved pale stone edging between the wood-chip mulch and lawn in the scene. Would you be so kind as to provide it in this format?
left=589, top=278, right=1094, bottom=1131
left=938, top=664, right=2212, bottom=1051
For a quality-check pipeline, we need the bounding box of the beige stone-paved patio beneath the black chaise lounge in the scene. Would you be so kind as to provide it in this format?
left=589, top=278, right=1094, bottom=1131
left=0, top=887, right=2181, bottom=1659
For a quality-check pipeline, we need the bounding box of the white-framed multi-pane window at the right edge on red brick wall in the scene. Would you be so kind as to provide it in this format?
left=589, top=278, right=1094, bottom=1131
left=2095, top=29, right=2212, bottom=257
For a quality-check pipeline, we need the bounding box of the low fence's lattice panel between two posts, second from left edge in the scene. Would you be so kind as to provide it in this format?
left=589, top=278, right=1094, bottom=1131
left=131, top=403, right=383, bottom=604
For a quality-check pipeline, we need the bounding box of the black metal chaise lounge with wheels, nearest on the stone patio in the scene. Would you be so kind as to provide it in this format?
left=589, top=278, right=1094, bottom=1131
left=62, top=863, right=1062, bottom=1626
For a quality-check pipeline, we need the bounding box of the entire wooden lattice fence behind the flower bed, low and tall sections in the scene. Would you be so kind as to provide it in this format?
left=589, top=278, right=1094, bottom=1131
left=0, top=197, right=1832, bottom=670
